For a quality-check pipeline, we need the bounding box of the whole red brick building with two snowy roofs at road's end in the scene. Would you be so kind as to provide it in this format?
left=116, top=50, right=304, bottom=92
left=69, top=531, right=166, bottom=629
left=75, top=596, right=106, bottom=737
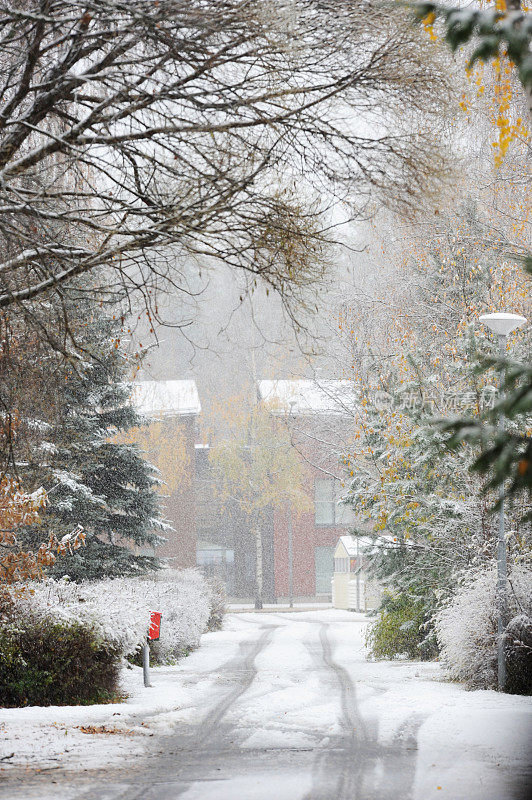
left=130, top=380, right=355, bottom=602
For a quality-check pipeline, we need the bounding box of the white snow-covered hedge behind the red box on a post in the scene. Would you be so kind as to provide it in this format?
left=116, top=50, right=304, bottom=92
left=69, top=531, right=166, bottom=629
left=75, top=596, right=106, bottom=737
left=9, top=569, right=213, bottom=661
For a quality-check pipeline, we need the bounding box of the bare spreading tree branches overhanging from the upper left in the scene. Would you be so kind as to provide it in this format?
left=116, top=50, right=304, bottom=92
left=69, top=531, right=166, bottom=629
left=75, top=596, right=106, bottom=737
left=0, top=0, right=454, bottom=332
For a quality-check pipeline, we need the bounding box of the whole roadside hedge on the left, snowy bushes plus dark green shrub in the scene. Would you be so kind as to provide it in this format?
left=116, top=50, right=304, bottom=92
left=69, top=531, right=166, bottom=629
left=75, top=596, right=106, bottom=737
left=0, top=570, right=225, bottom=706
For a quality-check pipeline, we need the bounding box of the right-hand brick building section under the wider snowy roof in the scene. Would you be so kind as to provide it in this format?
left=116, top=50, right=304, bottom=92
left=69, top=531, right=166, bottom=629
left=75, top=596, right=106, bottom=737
left=258, top=380, right=356, bottom=599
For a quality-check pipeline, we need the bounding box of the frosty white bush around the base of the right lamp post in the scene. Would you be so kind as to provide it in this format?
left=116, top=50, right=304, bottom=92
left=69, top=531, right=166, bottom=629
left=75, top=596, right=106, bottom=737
left=434, top=567, right=532, bottom=689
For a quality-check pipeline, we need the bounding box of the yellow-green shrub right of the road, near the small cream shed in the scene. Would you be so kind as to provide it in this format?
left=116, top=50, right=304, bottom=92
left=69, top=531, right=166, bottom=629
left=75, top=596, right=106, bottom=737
left=366, top=594, right=437, bottom=660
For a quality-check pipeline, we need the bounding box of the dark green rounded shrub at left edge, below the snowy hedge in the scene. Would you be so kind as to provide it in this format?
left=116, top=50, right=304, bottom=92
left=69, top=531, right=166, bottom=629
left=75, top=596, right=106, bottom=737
left=0, top=619, right=120, bottom=706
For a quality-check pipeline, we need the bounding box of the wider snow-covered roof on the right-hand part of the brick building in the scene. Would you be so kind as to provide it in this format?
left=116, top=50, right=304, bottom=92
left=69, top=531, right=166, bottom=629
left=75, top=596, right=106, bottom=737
left=258, top=380, right=356, bottom=414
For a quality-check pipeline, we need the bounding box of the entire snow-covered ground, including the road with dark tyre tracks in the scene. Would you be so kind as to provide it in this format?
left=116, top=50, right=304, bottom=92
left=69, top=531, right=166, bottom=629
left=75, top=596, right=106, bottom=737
left=0, top=609, right=532, bottom=800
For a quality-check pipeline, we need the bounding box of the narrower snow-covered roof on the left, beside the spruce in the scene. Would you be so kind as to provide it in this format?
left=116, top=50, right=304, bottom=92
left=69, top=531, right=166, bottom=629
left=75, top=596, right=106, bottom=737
left=132, top=380, right=201, bottom=417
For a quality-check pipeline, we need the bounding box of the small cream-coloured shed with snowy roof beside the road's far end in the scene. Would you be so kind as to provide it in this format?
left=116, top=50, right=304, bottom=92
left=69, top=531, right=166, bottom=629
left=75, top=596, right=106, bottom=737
left=331, top=536, right=381, bottom=611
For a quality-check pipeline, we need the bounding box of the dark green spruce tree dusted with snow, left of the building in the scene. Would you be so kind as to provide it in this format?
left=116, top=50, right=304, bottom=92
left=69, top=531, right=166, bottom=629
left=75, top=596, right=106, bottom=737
left=20, top=290, right=167, bottom=581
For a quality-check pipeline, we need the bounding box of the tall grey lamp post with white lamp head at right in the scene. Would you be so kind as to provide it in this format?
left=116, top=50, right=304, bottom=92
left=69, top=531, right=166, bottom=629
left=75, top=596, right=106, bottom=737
left=480, top=312, right=526, bottom=691
